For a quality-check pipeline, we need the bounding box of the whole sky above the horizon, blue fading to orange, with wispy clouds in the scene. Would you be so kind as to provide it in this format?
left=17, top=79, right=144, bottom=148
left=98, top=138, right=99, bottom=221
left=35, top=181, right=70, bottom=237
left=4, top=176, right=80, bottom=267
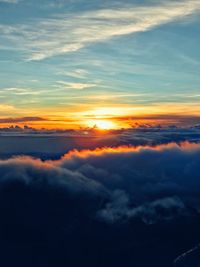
left=0, top=0, right=200, bottom=128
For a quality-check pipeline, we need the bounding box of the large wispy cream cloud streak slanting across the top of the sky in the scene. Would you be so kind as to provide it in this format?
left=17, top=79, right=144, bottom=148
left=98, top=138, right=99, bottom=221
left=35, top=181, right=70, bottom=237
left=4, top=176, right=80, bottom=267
left=0, top=0, right=200, bottom=60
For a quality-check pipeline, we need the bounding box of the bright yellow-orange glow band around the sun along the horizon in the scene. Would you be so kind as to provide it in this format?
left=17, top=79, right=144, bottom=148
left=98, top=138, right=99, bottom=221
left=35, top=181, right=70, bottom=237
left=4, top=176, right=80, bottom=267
left=0, top=103, right=200, bottom=130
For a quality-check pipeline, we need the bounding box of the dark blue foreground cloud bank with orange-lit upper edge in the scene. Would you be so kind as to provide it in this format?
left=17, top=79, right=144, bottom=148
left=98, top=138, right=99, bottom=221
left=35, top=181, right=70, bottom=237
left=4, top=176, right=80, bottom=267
left=0, top=143, right=200, bottom=267
